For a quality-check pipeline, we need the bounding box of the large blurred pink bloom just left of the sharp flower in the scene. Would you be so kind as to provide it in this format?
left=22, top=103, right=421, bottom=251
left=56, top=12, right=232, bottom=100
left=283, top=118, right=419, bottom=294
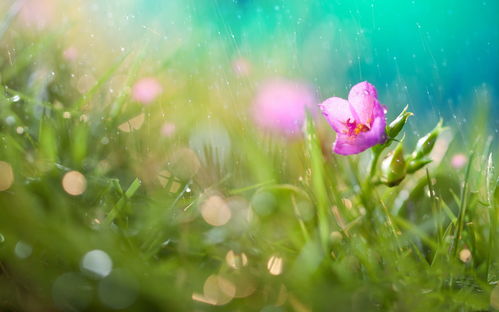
left=253, top=79, right=315, bottom=136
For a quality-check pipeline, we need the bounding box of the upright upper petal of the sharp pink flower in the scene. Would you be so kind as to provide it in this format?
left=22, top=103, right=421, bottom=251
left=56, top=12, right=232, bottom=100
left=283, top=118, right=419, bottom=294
left=348, top=81, right=379, bottom=125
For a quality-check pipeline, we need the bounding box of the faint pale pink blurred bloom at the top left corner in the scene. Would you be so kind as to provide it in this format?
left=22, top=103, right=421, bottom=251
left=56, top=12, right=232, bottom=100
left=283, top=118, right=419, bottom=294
left=19, top=0, right=55, bottom=29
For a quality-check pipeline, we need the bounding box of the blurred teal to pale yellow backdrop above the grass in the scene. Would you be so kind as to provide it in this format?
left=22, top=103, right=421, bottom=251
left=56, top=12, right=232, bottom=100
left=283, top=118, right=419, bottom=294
left=2, top=0, right=499, bottom=133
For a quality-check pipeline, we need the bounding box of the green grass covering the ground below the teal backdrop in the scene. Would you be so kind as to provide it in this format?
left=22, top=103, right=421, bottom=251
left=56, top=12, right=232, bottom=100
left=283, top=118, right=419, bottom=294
left=0, top=8, right=499, bottom=311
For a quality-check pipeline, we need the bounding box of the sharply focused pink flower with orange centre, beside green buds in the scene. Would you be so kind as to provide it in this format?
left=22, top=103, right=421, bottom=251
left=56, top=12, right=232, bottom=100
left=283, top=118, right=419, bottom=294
left=319, top=81, right=386, bottom=155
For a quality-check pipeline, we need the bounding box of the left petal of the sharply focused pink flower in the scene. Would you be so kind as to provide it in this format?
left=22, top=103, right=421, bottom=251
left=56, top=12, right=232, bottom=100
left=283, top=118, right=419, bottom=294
left=319, top=97, right=353, bottom=133
